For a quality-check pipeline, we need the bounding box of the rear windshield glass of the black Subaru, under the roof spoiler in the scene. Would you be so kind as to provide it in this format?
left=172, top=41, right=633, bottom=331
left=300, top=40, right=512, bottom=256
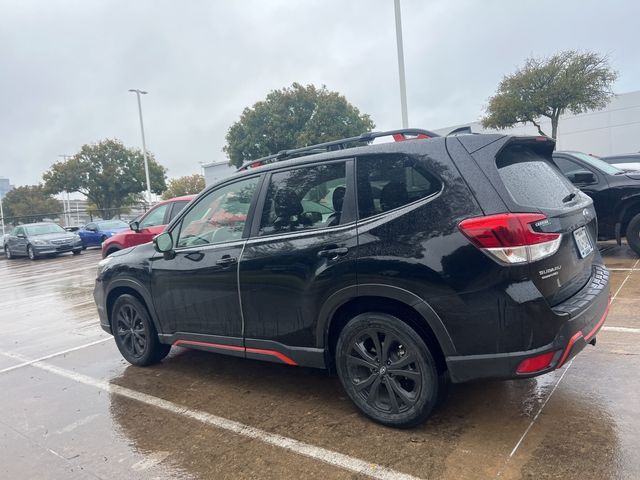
left=496, top=145, right=575, bottom=208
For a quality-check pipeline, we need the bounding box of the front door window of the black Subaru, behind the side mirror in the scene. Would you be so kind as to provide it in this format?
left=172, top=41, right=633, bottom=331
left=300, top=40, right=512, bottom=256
left=174, top=177, right=259, bottom=248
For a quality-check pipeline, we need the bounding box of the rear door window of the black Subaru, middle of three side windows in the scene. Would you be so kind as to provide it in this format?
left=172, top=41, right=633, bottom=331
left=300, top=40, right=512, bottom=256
left=259, top=162, right=347, bottom=235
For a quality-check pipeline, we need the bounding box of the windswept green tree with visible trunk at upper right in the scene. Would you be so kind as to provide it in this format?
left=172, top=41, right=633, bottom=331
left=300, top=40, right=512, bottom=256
left=482, top=50, right=618, bottom=138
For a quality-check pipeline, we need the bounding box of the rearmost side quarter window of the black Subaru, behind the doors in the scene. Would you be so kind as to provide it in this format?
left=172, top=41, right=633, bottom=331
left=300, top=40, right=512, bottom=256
left=357, top=155, right=442, bottom=218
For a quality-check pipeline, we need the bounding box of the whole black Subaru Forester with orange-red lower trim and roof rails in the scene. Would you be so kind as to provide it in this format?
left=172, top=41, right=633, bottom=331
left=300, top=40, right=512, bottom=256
left=95, top=130, right=609, bottom=427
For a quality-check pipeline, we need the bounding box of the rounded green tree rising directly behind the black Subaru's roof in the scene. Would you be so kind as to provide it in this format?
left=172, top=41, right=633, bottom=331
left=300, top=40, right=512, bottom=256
left=223, top=83, right=375, bottom=167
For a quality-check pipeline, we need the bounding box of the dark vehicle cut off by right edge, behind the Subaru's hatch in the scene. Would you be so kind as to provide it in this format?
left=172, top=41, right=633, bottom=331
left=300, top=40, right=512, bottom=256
left=553, top=151, right=640, bottom=255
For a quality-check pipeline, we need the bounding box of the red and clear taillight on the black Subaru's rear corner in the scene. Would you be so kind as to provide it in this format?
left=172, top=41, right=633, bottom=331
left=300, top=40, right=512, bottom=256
left=458, top=213, right=562, bottom=265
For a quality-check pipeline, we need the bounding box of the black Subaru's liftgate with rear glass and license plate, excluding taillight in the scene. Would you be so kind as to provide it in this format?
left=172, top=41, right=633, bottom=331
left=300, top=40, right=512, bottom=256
left=495, top=141, right=598, bottom=305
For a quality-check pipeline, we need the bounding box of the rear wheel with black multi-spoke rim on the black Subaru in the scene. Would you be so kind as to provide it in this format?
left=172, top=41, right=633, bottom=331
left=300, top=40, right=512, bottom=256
left=336, top=312, right=442, bottom=428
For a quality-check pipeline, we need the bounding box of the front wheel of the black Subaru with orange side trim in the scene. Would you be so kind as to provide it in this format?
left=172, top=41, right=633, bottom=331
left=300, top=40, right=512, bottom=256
left=111, top=294, right=171, bottom=367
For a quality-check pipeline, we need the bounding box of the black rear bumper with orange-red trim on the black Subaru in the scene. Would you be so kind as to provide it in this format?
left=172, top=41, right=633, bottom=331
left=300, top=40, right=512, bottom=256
left=446, top=264, right=609, bottom=383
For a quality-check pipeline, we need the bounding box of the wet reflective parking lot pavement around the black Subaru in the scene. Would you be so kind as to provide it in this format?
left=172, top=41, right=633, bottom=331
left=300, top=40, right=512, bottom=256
left=0, top=244, right=640, bottom=479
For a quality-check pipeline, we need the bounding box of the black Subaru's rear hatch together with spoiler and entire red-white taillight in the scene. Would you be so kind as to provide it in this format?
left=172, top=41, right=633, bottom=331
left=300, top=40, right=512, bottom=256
left=460, top=137, right=598, bottom=306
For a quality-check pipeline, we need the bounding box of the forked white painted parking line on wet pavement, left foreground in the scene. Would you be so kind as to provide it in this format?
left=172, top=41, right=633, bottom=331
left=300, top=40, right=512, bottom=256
left=0, top=348, right=418, bottom=480
